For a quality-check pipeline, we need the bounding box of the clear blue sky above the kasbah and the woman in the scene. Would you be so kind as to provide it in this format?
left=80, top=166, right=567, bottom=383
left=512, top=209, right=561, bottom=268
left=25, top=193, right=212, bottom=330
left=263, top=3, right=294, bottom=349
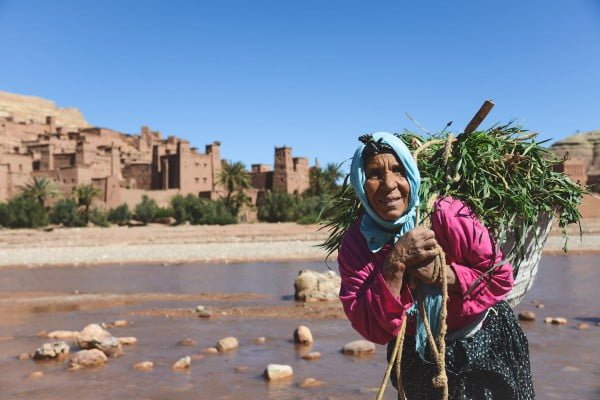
left=0, top=0, right=600, bottom=172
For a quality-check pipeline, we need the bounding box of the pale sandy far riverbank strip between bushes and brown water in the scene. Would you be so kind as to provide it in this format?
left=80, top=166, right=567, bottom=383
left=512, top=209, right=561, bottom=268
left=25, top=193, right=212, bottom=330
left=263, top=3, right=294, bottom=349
left=0, top=219, right=600, bottom=267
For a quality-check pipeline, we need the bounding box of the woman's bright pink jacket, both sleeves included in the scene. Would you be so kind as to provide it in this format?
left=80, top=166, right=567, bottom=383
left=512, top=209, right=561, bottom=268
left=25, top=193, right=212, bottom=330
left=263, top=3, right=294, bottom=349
left=338, top=197, right=513, bottom=344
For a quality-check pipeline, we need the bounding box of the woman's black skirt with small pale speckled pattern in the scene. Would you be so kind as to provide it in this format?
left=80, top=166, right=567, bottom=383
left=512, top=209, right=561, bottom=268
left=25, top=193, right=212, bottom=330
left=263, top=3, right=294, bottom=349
left=388, top=301, right=535, bottom=400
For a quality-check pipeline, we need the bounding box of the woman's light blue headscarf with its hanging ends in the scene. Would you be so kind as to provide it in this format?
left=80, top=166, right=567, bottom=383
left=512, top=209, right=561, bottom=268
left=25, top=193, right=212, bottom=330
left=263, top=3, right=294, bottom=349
left=350, top=132, right=442, bottom=359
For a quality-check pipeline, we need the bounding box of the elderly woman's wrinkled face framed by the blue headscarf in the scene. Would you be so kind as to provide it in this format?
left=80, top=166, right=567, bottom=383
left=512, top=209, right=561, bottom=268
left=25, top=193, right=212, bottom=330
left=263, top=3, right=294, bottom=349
left=365, top=153, right=410, bottom=221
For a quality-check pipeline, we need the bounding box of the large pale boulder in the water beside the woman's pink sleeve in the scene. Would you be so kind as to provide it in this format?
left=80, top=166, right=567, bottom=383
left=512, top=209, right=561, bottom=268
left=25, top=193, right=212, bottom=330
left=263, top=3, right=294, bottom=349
left=294, top=270, right=341, bottom=301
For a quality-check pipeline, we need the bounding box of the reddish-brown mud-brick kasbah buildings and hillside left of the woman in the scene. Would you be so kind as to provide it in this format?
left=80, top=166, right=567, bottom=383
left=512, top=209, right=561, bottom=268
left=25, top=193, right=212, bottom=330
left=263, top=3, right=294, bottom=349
left=0, top=91, right=309, bottom=208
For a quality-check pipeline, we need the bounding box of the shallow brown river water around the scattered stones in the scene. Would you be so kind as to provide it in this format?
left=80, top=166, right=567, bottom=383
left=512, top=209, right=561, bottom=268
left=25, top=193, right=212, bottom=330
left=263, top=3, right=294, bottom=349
left=0, top=256, right=600, bottom=400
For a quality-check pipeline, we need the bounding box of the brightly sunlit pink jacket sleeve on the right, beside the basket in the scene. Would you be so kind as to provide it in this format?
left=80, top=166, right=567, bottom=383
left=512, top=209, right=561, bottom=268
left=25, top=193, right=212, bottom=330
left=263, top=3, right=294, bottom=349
left=431, top=198, right=513, bottom=316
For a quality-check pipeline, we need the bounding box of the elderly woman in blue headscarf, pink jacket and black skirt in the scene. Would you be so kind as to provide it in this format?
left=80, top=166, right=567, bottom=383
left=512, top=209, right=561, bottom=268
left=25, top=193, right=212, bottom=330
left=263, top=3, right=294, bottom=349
left=338, top=132, right=535, bottom=400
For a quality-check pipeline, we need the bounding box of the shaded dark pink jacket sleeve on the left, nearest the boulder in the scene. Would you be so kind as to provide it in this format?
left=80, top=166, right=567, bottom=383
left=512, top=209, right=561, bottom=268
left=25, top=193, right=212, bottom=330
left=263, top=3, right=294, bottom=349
left=338, top=227, right=412, bottom=344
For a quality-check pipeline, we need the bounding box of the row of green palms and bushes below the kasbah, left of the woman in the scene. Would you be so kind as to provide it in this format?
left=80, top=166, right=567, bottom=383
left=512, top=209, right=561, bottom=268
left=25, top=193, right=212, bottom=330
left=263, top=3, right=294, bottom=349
left=0, top=162, right=341, bottom=228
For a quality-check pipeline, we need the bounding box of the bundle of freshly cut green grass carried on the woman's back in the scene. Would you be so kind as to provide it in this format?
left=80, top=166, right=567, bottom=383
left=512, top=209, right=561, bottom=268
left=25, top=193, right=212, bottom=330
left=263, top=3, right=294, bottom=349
left=321, top=124, right=586, bottom=302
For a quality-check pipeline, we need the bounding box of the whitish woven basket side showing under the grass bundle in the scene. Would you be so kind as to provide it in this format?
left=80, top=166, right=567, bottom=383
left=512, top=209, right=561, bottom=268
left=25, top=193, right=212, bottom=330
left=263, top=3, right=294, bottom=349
left=501, top=213, right=552, bottom=307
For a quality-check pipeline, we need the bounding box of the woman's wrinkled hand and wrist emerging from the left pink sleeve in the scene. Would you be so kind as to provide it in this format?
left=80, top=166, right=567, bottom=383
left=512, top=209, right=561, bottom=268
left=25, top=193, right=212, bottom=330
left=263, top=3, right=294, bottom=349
left=383, top=227, right=437, bottom=295
